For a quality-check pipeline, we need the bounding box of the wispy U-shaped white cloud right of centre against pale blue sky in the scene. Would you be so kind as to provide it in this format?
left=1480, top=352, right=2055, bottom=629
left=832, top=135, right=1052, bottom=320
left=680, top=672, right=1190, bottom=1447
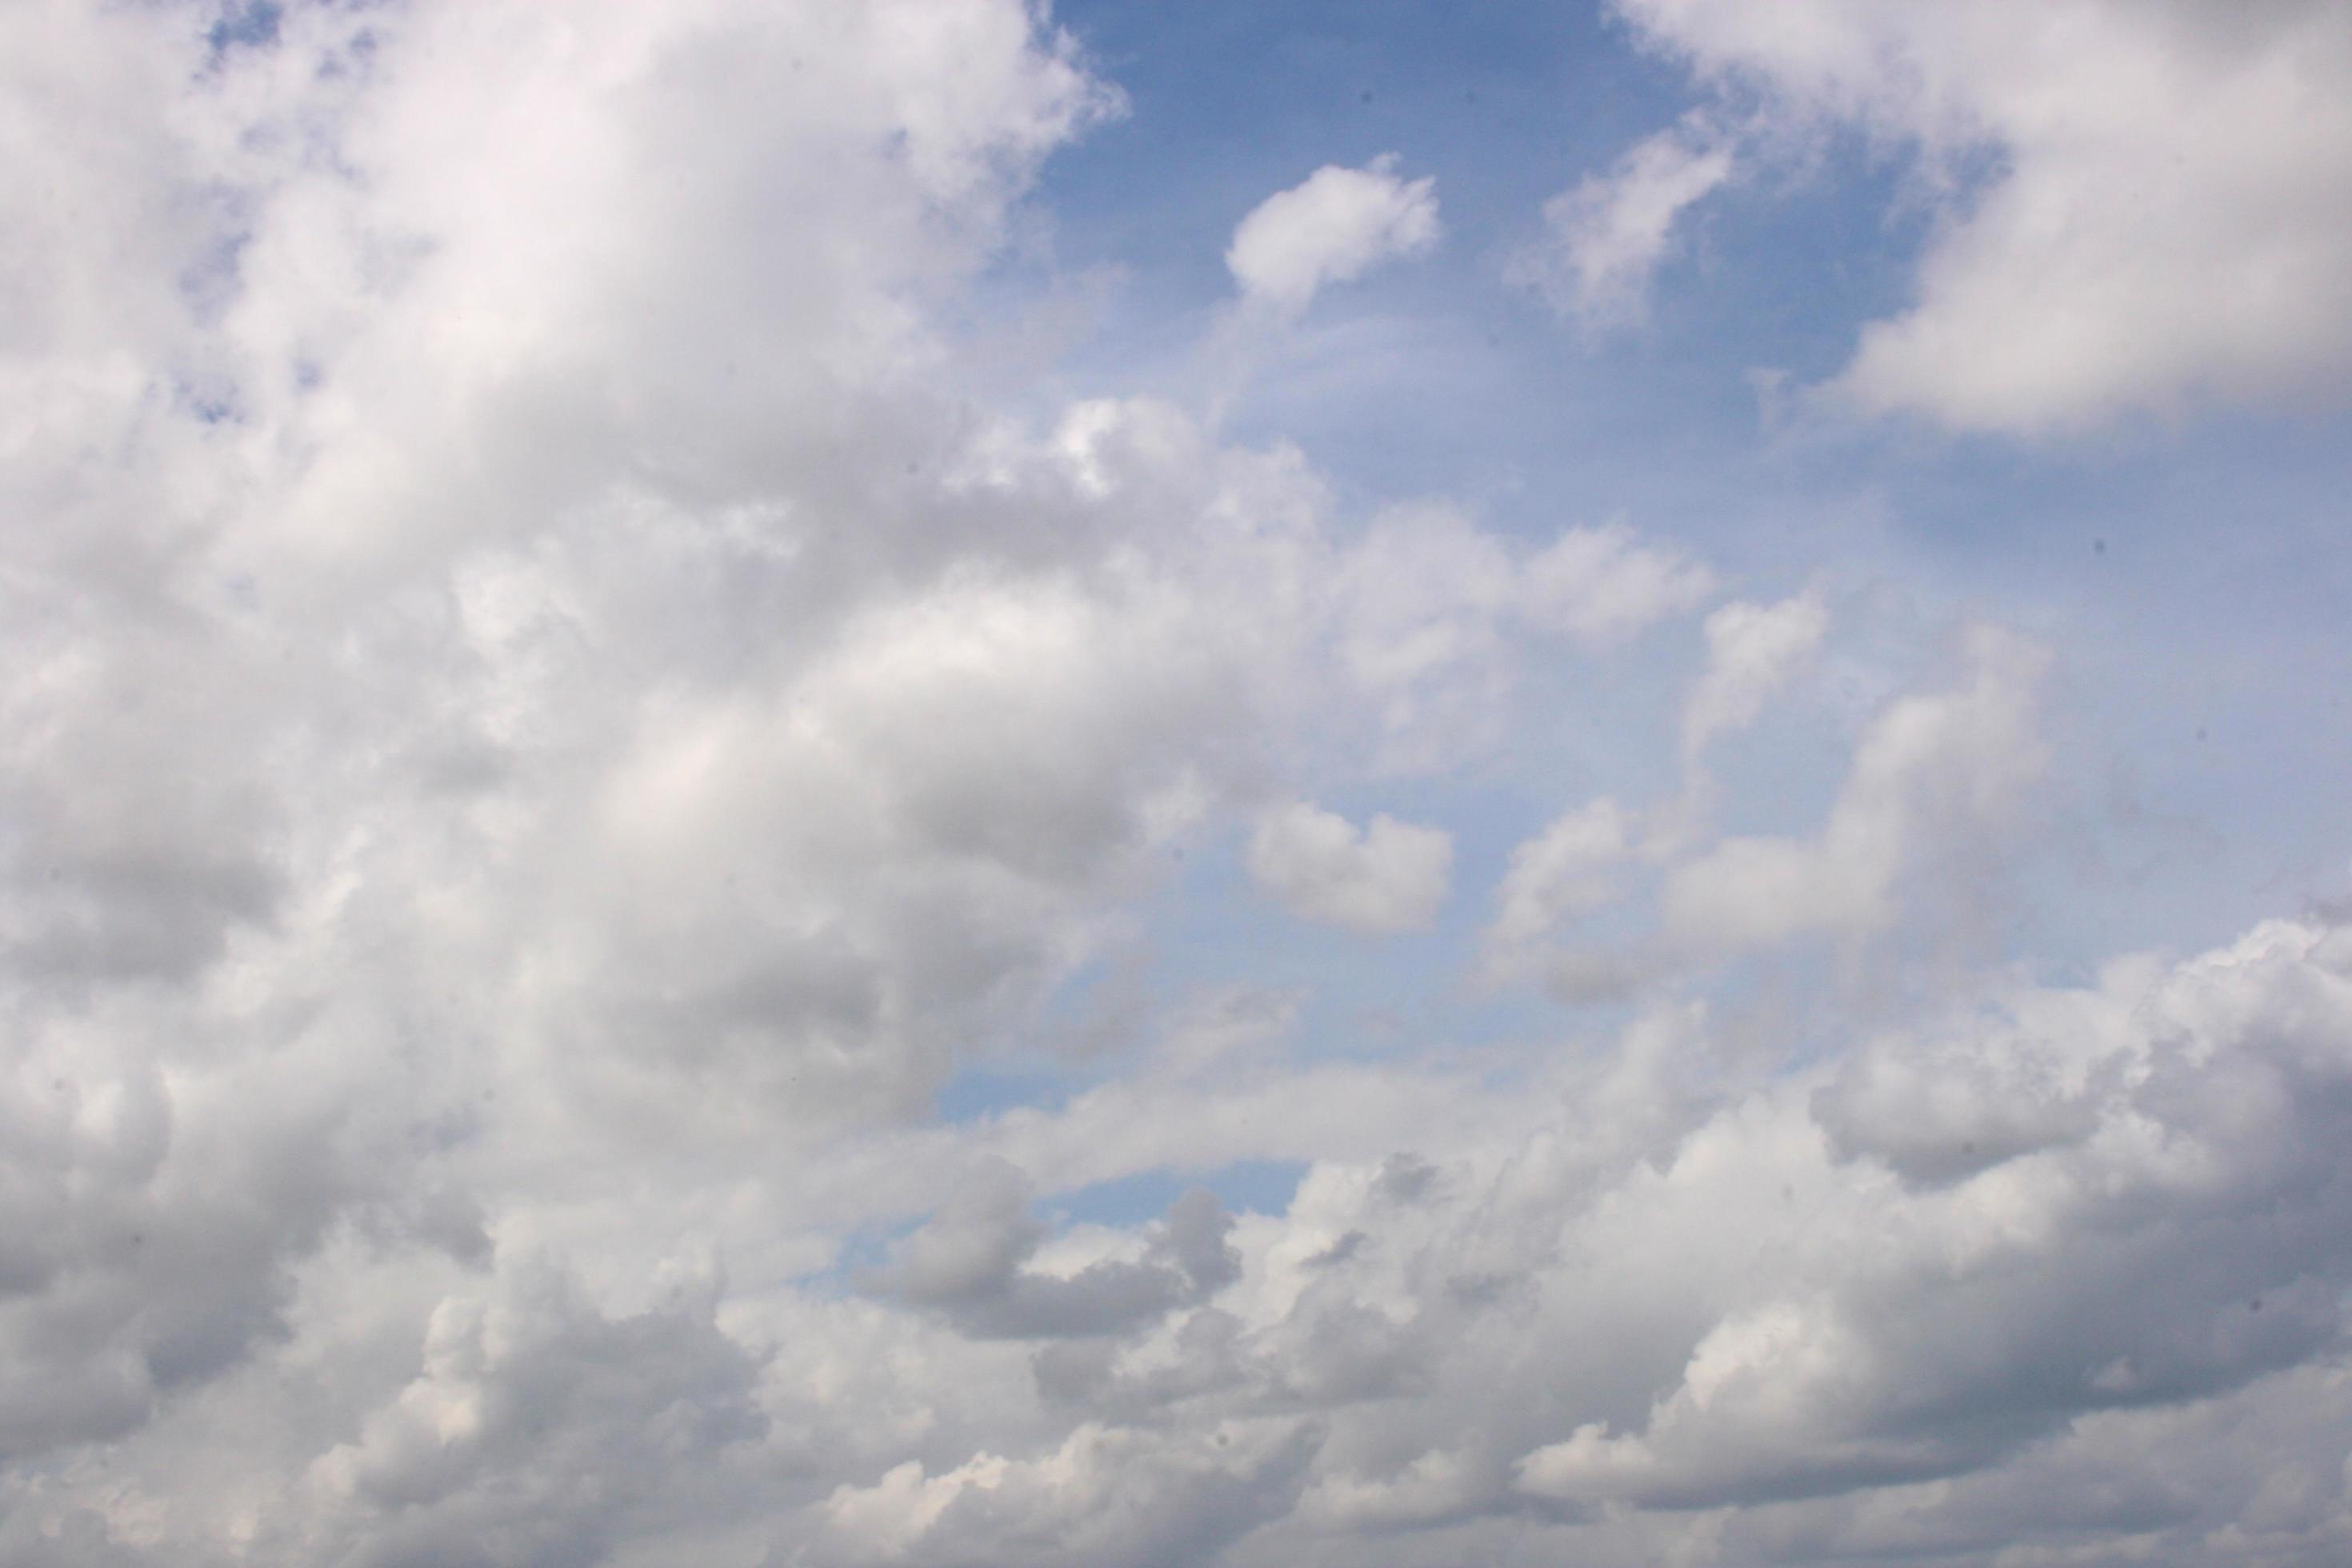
left=1482, top=625, right=2051, bottom=1002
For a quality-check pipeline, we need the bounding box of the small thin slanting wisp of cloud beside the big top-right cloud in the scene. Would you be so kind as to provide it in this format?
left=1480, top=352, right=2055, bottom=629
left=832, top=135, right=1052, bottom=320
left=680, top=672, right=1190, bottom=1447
left=1510, top=122, right=1736, bottom=326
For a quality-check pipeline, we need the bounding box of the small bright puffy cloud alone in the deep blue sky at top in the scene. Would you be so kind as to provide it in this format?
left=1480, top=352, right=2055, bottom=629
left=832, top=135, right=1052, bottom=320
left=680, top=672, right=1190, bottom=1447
left=1226, top=153, right=1439, bottom=313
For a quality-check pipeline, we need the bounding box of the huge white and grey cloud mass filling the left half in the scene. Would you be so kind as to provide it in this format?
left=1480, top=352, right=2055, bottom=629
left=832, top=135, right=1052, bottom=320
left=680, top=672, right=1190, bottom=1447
left=0, top=12, right=1693, bottom=1561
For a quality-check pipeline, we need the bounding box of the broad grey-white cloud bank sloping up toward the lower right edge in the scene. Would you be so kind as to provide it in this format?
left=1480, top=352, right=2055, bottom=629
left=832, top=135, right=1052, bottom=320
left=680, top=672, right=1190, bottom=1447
left=781, top=922, right=2352, bottom=1563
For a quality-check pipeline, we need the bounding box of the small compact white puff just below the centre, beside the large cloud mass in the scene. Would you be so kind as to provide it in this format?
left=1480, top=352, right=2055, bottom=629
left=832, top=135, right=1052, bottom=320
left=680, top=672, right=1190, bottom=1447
left=1249, top=802, right=1454, bottom=936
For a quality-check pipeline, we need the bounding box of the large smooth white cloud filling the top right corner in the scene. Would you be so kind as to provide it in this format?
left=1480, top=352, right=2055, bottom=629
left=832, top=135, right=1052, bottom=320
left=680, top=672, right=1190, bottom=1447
left=1599, top=0, right=2352, bottom=435
